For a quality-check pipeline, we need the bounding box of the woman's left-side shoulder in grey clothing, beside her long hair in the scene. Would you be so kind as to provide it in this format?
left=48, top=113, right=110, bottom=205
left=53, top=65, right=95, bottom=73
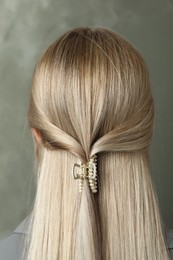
left=0, top=217, right=28, bottom=260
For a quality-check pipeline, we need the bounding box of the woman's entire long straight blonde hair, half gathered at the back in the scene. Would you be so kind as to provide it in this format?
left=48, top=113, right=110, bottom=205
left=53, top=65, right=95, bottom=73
left=23, top=27, right=169, bottom=260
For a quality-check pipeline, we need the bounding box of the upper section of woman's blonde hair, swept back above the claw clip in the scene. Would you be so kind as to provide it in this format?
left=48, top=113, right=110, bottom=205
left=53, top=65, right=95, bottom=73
left=29, top=25, right=154, bottom=161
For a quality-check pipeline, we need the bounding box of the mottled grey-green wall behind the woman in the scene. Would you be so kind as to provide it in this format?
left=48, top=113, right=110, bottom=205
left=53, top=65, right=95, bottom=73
left=0, top=0, right=173, bottom=240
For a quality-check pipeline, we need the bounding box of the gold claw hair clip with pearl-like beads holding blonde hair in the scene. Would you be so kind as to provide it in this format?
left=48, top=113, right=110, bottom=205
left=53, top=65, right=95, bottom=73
left=72, top=155, right=97, bottom=193
